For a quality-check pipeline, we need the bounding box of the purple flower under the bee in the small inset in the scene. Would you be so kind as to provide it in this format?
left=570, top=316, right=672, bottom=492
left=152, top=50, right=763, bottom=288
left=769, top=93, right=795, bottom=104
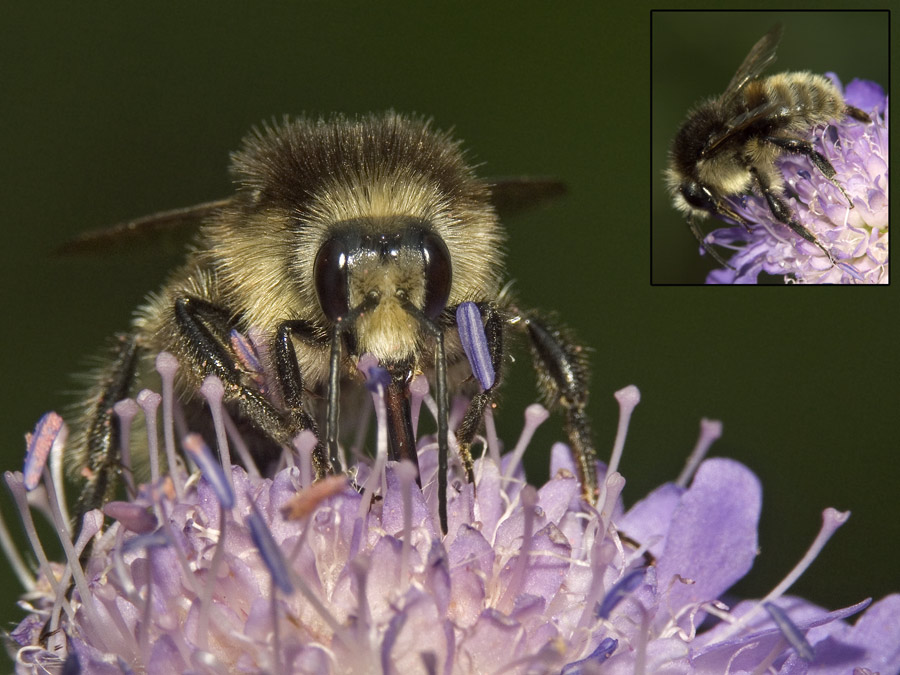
left=706, top=79, right=888, bottom=284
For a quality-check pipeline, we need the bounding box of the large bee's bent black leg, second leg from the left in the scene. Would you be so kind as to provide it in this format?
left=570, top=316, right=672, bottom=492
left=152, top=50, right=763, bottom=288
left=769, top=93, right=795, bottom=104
left=175, top=296, right=324, bottom=474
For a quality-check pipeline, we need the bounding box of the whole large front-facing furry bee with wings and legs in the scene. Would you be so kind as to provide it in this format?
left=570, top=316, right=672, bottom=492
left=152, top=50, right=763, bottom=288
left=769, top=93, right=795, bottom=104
left=67, top=113, right=597, bottom=532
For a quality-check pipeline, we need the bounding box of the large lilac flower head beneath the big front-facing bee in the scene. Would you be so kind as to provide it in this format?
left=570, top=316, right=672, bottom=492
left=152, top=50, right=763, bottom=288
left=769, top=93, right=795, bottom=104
left=6, top=354, right=900, bottom=675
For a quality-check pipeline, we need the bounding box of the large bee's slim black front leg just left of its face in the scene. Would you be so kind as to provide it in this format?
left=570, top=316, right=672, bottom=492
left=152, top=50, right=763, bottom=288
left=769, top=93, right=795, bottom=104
left=274, top=319, right=332, bottom=480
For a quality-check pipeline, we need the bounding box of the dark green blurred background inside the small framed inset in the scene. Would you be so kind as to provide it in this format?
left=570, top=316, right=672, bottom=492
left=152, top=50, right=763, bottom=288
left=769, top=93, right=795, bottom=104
left=651, top=11, right=889, bottom=284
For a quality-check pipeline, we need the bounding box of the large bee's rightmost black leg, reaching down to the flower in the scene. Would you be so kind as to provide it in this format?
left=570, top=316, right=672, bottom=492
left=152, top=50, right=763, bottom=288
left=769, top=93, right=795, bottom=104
left=516, top=313, right=597, bottom=504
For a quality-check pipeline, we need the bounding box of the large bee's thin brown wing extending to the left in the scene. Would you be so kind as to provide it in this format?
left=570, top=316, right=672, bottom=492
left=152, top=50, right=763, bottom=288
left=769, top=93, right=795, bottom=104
left=56, top=198, right=232, bottom=255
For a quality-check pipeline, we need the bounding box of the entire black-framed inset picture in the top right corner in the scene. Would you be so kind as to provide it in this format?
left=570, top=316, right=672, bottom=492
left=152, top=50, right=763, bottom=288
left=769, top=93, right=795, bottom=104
left=651, top=11, right=890, bottom=285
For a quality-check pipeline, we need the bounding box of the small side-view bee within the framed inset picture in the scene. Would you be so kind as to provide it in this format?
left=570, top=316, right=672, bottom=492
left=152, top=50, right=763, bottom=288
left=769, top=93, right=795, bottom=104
left=666, top=24, right=871, bottom=266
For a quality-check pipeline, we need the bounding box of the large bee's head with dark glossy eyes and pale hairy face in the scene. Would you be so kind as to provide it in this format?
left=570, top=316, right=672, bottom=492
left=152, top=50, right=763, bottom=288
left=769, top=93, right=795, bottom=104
left=313, top=217, right=452, bottom=361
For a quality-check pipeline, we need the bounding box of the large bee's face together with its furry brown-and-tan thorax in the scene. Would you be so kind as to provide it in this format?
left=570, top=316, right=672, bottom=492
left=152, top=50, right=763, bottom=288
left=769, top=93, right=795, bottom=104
left=198, top=113, right=505, bottom=363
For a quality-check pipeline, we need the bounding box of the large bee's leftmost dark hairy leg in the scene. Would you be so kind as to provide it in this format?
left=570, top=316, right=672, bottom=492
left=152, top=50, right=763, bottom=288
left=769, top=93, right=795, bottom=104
left=74, top=335, right=139, bottom=524
